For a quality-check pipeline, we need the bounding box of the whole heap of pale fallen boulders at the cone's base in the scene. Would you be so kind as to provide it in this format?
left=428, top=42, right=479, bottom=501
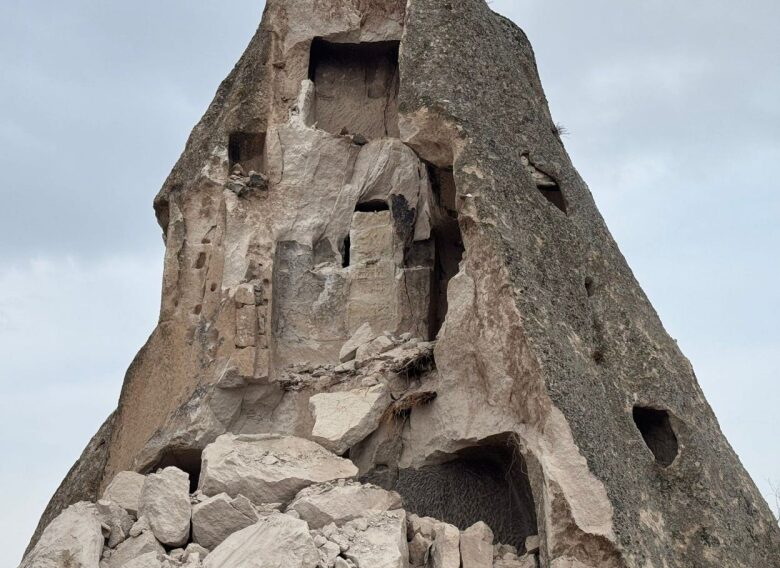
left=20, top=442, right=539, bottom=568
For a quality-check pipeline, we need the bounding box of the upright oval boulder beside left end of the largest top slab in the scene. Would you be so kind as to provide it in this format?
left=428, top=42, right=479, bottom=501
left=139, top=467, right=192, bottom=547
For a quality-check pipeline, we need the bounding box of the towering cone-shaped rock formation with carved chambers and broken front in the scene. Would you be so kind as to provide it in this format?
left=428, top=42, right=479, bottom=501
left=27, top=0, right=780, bottom=568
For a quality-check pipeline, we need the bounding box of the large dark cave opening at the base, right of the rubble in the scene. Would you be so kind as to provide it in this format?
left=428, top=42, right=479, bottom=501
left=395, top=435, right=538, bottom=551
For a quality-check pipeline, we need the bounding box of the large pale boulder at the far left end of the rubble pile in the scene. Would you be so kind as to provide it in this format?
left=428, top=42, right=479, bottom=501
left=19, top=503, right=103, bottom=568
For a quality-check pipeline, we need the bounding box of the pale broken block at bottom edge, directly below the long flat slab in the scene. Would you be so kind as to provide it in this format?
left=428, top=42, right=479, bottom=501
left=341, top=511, right=409, bottom=568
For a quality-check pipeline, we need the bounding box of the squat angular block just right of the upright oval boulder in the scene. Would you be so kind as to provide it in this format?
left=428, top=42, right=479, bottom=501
left=192, top=493, right=257, bottom=550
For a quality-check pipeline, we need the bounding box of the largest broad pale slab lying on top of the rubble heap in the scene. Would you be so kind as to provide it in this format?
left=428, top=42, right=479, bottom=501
left=199, top=434, right=357, bottom=504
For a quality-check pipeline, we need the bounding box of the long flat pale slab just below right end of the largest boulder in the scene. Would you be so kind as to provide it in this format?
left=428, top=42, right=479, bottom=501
left=287, top=481, right=402, bottom=529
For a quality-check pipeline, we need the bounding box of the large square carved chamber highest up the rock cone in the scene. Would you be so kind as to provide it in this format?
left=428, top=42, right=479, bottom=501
left=309, top=38, right=400, bottom=139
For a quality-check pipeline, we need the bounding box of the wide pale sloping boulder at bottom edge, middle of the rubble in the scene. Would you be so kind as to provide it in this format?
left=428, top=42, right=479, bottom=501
left=203, top=513, right=320, bottom=568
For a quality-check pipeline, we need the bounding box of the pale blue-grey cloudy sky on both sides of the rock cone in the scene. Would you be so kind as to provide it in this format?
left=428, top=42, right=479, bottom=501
left=0, top=0, right=780, bottom=568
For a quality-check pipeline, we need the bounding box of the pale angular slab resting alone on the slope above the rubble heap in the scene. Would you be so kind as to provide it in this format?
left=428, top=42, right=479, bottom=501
left=309, top=385, right=390, bottom=454
